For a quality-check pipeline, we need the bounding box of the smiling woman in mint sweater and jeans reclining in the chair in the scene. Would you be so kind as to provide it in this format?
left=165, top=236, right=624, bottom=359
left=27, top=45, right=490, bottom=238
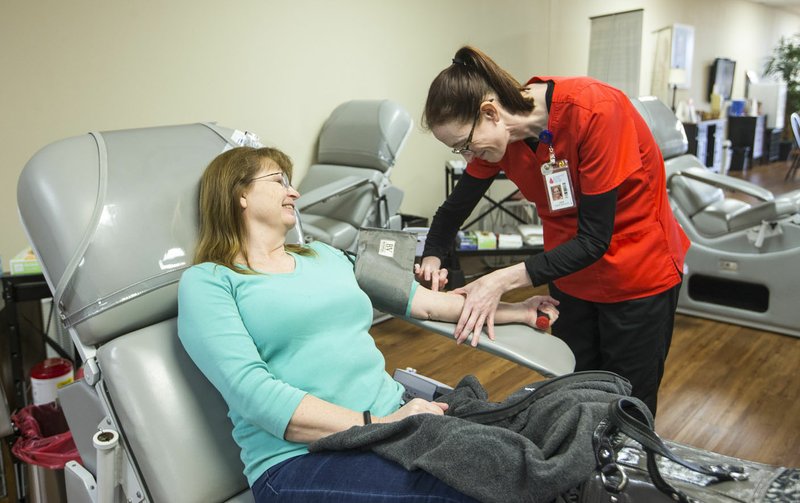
left=178, top=147, right=558, bottom=502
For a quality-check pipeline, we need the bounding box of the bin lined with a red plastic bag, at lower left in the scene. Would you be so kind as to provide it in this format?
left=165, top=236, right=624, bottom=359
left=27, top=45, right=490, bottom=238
left=11, top=402, right=81, bottom=503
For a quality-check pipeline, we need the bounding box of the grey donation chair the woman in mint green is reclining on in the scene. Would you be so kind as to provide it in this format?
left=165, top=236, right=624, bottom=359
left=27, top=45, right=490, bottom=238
left=17, top=118, right=574, bottom=503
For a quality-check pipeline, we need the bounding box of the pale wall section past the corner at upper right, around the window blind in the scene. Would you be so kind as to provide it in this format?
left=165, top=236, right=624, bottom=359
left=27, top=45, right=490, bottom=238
left=549, top=0, right=800, bottom=110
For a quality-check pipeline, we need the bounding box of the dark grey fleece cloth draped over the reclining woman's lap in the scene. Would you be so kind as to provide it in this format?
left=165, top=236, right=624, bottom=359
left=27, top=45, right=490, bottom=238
left=309, top=372, right=630, bottom=503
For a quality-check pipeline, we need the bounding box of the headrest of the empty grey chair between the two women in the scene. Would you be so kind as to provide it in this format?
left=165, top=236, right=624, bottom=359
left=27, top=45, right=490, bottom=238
left=317, top=100, right=413, bottom=172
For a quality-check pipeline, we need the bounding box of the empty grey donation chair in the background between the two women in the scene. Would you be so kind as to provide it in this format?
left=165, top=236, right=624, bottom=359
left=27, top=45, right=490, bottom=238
left=297, top=100, right=413, bottom=252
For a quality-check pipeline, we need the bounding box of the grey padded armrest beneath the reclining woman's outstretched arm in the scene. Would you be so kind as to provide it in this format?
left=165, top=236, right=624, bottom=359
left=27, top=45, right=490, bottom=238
left=403, top=317, right=575, bottom=377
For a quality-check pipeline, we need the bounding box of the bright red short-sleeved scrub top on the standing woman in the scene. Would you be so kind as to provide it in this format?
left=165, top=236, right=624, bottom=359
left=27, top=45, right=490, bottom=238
left=467, top=77, right=689, bottom=302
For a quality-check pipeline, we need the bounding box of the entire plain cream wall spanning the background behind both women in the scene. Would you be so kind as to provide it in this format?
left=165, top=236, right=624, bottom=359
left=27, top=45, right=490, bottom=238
left=0, top=0, right=800, bottom=269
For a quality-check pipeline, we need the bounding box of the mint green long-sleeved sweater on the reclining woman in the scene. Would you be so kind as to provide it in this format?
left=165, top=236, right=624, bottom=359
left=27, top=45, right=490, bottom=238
left=178, top=242, right=417, bottom=485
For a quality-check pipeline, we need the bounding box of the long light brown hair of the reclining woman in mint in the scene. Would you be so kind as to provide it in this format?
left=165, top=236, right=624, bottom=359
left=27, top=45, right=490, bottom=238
left=194, top=147, right=314, bottom=274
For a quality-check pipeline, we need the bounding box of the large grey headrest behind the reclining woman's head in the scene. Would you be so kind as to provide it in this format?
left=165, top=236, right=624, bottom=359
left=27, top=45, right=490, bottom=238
left=17, top=124, right=239, bottom=345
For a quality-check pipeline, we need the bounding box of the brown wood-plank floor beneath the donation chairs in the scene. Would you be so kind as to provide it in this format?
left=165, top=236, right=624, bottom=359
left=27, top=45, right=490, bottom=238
left=372, top=162, right=800, bottom=467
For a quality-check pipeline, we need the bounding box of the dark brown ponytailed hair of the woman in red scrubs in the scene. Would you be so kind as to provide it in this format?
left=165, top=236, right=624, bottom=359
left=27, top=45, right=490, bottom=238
left=422, top=46, right=534, bottom=129
